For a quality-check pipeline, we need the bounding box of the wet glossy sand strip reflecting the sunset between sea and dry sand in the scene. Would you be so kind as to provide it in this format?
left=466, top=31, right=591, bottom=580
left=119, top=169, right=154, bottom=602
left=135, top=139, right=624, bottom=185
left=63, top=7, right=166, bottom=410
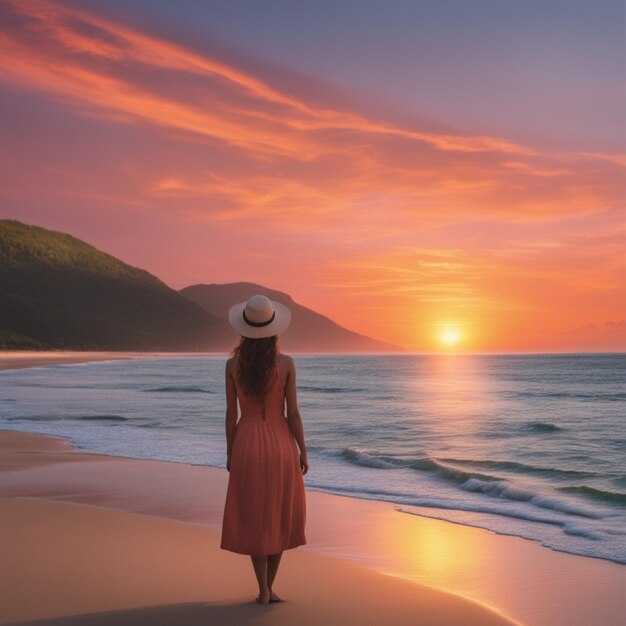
left=0, top=430, right=626, bottom=626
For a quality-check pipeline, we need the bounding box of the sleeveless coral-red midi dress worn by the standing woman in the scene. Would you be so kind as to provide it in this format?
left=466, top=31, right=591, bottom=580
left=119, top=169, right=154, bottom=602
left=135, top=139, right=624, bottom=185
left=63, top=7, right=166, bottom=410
left=221, top=357, right=306, bottom=556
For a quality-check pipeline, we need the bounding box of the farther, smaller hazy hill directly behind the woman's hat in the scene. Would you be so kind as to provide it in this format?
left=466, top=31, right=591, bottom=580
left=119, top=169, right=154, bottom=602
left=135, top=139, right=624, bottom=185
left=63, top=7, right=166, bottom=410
left=180, top=282, right=404, bottom=352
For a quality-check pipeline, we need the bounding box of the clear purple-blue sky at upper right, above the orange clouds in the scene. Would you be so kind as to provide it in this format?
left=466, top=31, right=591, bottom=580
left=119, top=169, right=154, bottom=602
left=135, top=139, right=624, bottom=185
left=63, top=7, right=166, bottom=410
left=77, top=0, right=626, bottom=151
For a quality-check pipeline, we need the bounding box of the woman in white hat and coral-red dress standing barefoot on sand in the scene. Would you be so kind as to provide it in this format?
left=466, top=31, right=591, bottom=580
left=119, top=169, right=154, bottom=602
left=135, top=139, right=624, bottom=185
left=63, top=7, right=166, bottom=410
left=221, top=295, right=309, bottom=604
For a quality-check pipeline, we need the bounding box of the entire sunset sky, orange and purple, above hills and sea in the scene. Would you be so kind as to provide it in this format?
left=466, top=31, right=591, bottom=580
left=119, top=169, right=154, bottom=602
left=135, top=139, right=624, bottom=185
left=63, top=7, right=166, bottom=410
left=0, top=0, right=626, bottom=352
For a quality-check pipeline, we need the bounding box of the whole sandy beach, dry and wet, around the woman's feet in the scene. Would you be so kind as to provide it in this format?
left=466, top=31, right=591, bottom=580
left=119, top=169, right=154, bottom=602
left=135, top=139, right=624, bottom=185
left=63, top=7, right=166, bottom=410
left=0, top=431, right=624, bottom=626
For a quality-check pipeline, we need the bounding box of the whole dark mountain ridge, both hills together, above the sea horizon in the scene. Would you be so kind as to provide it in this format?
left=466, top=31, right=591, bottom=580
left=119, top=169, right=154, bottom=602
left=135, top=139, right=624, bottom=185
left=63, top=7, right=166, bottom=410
left=0, top=220, right=402, bottom=352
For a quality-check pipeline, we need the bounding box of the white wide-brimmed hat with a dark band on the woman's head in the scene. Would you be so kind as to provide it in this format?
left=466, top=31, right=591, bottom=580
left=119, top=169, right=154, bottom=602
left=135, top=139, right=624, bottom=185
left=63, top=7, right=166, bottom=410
left=228, top=295, right=291, bottom=339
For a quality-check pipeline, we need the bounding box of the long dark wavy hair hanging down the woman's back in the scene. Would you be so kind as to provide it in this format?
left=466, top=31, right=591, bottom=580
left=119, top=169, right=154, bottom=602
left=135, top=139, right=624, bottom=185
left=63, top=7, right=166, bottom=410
left=231, top=335, right=279, bottom=400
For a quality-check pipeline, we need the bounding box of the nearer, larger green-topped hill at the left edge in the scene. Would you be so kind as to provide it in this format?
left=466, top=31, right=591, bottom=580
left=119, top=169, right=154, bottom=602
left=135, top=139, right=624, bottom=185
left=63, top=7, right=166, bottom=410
left=0, top=220, right=230, bottom=351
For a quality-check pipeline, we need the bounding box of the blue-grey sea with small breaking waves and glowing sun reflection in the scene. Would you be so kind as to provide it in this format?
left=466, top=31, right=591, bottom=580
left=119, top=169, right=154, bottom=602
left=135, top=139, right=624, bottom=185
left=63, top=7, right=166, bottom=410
left=0, top=354, right=626, bottom=563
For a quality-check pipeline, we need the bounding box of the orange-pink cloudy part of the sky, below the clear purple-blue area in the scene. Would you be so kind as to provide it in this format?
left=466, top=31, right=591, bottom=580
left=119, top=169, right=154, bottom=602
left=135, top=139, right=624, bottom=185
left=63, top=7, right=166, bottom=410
left=0, top=0, right=626, bottom=352
